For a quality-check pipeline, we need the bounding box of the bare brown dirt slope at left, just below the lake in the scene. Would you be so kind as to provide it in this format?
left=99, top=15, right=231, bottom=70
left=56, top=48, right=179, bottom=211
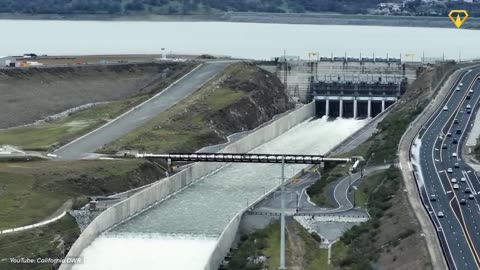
left=0, top=62, right=196, bottom=128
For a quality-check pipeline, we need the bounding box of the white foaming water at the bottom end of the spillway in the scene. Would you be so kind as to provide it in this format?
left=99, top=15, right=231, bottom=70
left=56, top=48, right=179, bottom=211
left=74, top=234, right=216, bottom=270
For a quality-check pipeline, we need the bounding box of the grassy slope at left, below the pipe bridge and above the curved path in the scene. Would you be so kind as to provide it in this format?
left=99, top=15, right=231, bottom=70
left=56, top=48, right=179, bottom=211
left=0, top=160, right=163, bottom=229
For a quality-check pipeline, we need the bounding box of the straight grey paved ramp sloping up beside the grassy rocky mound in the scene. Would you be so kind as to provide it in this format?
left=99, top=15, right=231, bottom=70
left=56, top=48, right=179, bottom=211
left=54, top=62, right=229, bottom=160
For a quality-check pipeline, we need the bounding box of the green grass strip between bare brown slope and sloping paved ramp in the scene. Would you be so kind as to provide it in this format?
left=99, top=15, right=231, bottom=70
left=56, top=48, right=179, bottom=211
left=0, top=95, right=144, bottom=151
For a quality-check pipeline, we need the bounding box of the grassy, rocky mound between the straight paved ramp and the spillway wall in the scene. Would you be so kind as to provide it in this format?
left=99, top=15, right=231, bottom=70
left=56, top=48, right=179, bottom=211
left=101, top=63, right=294, bottom=153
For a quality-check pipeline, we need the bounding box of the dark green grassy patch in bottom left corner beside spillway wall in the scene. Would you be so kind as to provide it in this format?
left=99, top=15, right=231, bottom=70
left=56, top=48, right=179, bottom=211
left=0, top=215, right=80, bottom=270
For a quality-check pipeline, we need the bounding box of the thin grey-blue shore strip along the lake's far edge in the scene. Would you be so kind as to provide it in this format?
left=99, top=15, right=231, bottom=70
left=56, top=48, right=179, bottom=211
left=0, top=12, right=480, bottom=30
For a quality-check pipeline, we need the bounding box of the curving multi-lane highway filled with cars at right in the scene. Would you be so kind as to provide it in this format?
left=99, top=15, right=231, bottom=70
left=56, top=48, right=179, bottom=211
left=411, top=68, right=480, bottom=270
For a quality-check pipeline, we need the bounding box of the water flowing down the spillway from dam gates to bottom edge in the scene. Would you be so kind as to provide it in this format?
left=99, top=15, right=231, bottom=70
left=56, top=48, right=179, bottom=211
left=74, top=117, right=367, bottom=270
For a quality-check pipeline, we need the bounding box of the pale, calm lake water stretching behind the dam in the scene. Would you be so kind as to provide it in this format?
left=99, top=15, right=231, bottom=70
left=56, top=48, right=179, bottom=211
left=0, top=18, right=480, bottom=60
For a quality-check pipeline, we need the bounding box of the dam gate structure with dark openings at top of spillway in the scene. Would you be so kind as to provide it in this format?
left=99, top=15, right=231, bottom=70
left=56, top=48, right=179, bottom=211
left=309, top=76, right=407, bottom=118
